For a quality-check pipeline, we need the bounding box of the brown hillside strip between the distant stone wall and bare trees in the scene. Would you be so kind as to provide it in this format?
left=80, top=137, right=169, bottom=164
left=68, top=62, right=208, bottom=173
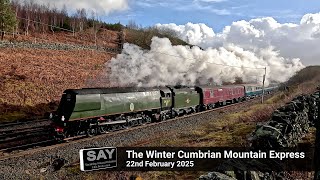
left=4, top=25, right=192, bottom=49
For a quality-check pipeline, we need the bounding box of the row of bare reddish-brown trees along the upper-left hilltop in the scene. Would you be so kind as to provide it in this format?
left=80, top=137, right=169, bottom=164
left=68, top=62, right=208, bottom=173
left=8, top=0, right=124, bottom=36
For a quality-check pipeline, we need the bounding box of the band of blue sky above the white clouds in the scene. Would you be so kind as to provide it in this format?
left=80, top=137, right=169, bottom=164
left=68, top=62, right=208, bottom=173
left=101, top=0, right=320, bottom=32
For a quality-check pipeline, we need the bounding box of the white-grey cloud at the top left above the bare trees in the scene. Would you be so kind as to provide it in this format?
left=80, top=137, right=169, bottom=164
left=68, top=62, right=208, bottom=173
left=28, top=0, right=128, bottom=15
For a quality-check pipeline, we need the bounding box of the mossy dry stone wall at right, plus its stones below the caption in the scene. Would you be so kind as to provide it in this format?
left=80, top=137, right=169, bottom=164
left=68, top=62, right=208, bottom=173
left=199, top=93, right=319, bottom=180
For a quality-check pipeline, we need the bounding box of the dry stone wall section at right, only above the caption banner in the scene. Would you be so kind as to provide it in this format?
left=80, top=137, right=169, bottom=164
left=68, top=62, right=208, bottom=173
left=250, top=94, right=317, bottom=148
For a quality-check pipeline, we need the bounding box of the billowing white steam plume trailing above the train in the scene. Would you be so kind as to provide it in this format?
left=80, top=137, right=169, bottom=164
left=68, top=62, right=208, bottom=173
left=107, top=37, right=303, bottom=86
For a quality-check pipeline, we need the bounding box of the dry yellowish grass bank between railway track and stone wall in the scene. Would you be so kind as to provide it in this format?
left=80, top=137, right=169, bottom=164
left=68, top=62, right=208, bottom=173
left=152, top=101, right=276, bottom=147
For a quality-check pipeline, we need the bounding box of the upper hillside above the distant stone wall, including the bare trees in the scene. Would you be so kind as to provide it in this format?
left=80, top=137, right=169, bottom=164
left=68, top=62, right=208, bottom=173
left=0, top=0, right=188, bottom=49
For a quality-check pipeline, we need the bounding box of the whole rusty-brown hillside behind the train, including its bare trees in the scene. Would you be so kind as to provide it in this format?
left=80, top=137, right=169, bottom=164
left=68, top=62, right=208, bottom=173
left=0, top=0, right=191, bottom=122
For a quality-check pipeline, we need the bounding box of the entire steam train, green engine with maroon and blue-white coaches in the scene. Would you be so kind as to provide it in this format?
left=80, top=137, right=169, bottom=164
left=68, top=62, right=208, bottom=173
left=50, top=84, right=277, bottom=140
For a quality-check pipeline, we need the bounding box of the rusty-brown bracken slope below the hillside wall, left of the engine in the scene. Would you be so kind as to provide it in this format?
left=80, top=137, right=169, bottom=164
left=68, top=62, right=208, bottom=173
left=0, top=48, right=112, bottom=121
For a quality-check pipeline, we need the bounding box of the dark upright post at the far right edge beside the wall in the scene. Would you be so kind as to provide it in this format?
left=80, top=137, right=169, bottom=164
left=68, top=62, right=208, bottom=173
left=314, top=87, right=320, bottom=180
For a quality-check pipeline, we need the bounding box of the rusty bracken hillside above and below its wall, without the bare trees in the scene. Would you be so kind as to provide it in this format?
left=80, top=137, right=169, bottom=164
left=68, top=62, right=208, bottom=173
left=0, top=22, right=190, bottom=122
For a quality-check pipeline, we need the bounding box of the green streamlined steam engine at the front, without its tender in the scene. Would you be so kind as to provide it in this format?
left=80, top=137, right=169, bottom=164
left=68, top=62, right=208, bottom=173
left=51, top=88, right=172, bottom=137
